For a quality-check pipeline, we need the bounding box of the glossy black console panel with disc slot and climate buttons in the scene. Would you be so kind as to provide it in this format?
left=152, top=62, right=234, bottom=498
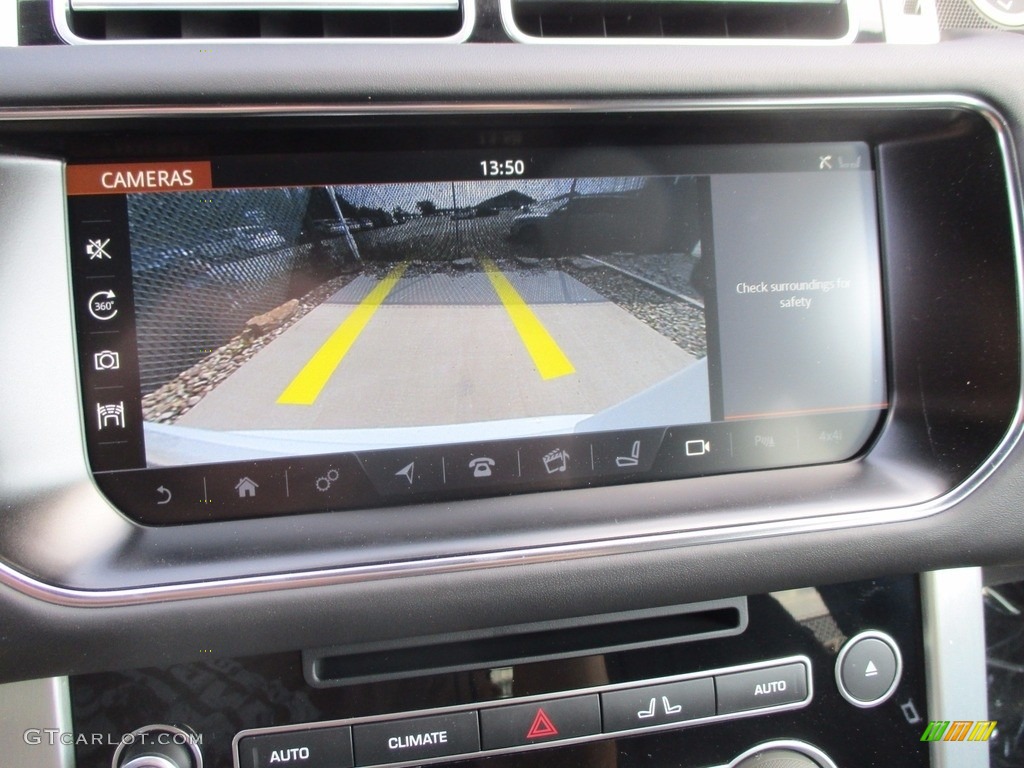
left=71, top=579, right=929, bottom=768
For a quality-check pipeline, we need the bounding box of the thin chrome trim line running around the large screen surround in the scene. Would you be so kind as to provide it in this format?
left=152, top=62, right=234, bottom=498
left=0, top=94, right=1024, bottom=607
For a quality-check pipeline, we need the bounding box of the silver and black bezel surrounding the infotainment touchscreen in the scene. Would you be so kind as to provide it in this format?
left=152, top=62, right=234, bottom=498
left=0, top=96, right=1020, bottom=605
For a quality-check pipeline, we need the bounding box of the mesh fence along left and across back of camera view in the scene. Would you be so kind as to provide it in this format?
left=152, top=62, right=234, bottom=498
left=128, top=177, right=695, bottom=394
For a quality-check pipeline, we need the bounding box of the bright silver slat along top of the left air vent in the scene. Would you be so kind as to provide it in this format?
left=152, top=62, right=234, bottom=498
left=71, top=0, right=459, bottom=11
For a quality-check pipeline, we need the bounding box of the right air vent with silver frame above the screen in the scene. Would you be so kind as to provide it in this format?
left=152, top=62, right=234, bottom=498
left=502, top=0, right=855, bottom=42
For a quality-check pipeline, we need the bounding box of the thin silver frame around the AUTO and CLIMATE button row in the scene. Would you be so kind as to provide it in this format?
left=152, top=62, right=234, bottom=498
left=231, top=655, right=814, bottom=768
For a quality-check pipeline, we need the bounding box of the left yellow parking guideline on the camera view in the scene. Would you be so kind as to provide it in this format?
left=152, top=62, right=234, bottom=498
left=278, top=261, right=409, bottom=406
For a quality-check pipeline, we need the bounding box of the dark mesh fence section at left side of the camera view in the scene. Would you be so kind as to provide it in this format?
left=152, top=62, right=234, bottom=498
left=128, top=188, right=325, bottom=393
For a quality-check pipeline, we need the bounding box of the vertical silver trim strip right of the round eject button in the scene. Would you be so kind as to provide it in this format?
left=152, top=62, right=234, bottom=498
left=921, top=568, right=989, bottom=768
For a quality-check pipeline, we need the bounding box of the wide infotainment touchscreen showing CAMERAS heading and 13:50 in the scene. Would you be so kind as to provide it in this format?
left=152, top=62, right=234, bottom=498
left=68, top=143, right=886, bottom=522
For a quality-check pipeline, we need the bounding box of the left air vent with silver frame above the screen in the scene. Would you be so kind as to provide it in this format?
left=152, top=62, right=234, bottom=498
left=54, top=0, right=473, bottom=42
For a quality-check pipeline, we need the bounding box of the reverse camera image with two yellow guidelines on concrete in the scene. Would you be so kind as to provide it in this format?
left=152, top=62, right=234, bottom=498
left=128, top=176, right=711, bottom=466
